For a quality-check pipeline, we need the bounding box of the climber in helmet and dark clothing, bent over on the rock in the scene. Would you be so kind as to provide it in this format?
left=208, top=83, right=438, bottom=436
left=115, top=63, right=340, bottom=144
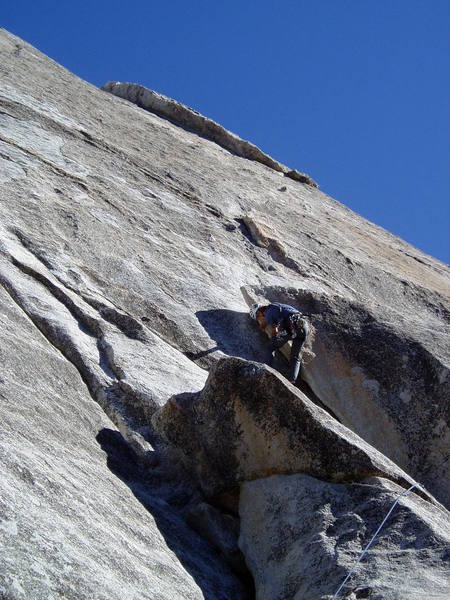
left=250, top=303, right=311, bottom=385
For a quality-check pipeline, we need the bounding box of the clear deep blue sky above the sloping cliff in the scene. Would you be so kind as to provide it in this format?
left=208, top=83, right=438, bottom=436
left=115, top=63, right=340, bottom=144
left=0, top=0, right=450, bottom=262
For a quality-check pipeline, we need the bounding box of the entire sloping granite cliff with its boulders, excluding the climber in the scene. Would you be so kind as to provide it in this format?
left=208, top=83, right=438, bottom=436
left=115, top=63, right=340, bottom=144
left=0, top=30, right=450, bottom=600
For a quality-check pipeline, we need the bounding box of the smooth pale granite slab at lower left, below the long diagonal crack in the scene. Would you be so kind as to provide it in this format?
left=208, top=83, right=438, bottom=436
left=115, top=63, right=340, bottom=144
left=0, top=287, right=244, bottom=600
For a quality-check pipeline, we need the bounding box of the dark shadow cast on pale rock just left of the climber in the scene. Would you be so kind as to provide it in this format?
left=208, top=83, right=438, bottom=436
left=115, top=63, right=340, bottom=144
left=193, top=308, right=269, bottom=362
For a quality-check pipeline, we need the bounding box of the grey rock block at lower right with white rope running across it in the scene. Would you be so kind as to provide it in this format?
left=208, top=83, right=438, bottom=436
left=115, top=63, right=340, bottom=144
left=239, top=474, right=450, bottom=600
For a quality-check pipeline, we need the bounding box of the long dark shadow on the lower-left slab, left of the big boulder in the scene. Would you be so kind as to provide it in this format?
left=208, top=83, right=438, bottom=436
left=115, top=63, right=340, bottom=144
left=96, top=428, right=255, bottom=600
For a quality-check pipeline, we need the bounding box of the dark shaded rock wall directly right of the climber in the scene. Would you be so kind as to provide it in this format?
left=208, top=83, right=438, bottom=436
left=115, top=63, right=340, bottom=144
left=253, top=288, right=450, bottom=506
